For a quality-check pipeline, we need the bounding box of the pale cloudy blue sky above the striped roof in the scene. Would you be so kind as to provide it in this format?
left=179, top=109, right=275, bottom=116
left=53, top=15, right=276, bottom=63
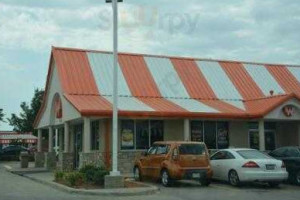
left=0, top=0, right=300, bottom=130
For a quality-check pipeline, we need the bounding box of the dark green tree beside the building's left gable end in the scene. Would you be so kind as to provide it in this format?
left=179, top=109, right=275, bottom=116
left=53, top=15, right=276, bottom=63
left=7, top=89, right=44, bottom=133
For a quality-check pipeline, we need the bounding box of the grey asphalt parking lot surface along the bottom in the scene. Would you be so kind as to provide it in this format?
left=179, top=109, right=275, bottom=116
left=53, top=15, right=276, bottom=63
left=0, top=163, right=300, bottom=200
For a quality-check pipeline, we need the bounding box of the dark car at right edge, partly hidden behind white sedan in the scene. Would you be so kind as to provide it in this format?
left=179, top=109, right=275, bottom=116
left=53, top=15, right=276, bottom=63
left=269, top=147, right=300, bottom=185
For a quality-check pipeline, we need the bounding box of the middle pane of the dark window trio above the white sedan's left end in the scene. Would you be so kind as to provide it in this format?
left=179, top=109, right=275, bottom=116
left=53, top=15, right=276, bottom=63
left=204, top=121, right=217, bottom=149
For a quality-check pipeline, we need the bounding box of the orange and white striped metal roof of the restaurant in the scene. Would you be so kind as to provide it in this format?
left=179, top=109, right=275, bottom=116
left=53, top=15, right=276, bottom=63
left=35, top=47, right=300, bottom=122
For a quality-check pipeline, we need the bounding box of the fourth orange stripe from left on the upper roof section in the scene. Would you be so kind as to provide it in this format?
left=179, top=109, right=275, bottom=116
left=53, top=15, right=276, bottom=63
left=219, top=62, right=265, bottom=99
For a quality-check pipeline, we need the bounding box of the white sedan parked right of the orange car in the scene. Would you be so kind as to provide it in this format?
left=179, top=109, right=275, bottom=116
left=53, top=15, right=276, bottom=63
left=210, top=149, right=288, bottom=187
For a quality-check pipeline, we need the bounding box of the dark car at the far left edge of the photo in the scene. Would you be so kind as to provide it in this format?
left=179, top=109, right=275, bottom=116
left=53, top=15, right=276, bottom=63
left=0, top=145, right=30, bottom=160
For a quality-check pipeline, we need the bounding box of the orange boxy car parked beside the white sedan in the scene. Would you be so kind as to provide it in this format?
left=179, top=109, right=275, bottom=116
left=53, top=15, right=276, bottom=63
left=133, top=141, right=212, bottom=186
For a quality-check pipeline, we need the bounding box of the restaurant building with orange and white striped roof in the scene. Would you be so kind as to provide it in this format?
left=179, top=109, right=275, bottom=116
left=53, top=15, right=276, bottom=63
left=35, top=47, right=300, bottom=173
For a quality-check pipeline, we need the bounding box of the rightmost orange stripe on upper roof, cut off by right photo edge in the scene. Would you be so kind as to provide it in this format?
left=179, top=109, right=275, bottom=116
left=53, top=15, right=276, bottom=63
left=266, top=65, right=300, bottom=95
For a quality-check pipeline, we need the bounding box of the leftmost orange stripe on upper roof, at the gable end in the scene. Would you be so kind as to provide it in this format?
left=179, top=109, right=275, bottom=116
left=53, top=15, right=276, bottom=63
left=53, top=49, right=99, bottom=95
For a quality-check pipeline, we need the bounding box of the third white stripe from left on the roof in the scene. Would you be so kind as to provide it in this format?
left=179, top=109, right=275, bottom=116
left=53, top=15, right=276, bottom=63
left=196, top=61, right=245, bottom=110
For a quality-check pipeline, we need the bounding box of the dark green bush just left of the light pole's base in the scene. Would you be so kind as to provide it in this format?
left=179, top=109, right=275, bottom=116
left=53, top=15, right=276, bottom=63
left=80, top=165, right=108, bottom=185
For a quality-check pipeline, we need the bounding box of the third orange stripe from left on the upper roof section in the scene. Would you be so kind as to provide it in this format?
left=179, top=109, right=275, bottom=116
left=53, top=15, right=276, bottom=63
left=171, top=58, right=217, bottom=99
